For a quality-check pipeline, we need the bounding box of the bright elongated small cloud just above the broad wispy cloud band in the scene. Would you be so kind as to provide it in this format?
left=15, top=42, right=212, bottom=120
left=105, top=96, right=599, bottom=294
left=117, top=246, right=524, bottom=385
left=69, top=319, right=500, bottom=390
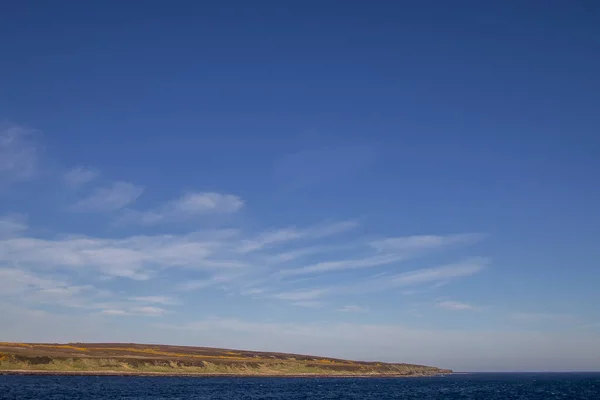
left=121, top=192, right=244, bottom=225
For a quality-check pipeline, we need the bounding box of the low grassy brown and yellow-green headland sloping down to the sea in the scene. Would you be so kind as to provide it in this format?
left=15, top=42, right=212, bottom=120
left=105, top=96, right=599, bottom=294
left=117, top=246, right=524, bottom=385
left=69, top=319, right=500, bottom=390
left=0, top=342, right=451, bottom=376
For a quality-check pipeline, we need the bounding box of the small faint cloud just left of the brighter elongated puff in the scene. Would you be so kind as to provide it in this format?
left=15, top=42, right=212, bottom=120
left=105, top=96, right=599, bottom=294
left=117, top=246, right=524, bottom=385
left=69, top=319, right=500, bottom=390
left=73, top=182, right=144, bottom=211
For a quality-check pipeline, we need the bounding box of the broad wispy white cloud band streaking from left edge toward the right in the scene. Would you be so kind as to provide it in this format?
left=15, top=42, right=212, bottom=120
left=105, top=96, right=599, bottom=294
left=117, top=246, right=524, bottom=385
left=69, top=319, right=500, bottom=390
left=0, top=214, right=486, bottom=312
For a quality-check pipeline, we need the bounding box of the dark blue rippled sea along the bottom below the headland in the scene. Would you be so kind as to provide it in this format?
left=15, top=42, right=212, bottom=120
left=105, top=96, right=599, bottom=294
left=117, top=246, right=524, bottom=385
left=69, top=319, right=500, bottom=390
left=0, top=373, right=600, bottom=400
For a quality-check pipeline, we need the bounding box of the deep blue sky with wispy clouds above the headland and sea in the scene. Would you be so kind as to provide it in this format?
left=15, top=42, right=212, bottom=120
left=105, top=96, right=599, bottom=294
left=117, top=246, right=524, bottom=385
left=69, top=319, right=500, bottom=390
left=0, top=1, right=600, bottom=370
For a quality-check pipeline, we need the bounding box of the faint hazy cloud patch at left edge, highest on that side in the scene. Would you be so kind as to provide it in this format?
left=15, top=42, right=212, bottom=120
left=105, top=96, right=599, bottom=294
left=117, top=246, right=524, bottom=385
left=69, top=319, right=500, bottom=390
left=0, top=123, right=40, bottom=181
